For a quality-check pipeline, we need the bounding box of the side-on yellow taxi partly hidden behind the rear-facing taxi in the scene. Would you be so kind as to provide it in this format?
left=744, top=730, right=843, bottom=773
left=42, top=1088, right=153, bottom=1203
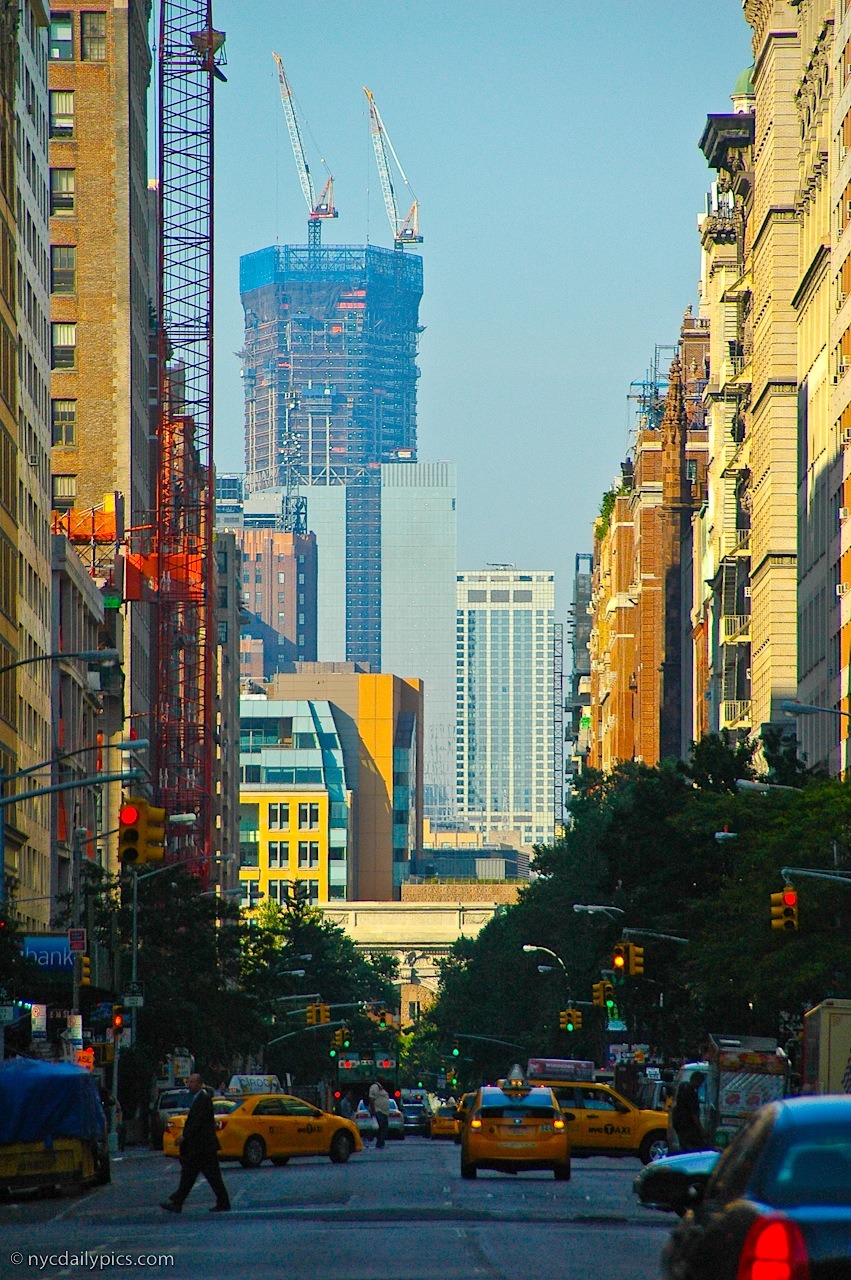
left=536, top=1080, right=668, bottom=1165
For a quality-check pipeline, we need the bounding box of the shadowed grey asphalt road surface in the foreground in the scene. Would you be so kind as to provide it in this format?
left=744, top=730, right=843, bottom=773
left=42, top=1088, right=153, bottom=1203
left=0, top=1138, right=672, bottom=1280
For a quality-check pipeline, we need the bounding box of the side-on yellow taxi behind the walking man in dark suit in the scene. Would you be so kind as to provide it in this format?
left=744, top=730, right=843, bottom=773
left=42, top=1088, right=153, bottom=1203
left=164, top=1093, right=363, bottom=1169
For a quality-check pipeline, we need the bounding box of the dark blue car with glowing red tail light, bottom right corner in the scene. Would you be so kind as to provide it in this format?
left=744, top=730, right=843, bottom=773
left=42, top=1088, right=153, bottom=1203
left=648, top=1094, right=851, bottom=1280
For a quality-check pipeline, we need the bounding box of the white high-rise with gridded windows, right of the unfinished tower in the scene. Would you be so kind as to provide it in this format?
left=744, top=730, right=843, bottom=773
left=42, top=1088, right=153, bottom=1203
left=456, top=566, right=555, bottom=845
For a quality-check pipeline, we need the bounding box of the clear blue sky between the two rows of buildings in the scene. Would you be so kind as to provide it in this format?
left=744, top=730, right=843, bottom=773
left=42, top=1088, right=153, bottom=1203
left=214, top=0, right=751, bottom=608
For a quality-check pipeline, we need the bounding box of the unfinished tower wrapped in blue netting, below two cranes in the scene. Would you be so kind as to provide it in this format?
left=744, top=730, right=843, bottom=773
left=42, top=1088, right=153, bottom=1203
left=239, top=244, right=422, bottom=671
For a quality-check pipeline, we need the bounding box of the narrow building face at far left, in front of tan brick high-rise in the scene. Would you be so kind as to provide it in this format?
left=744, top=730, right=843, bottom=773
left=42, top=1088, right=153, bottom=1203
left=15, top=0, right=53, bottom=927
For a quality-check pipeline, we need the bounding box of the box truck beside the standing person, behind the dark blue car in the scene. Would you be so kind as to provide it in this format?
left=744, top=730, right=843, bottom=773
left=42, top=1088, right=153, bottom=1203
left=706, top=1036, right=790, bottom=1148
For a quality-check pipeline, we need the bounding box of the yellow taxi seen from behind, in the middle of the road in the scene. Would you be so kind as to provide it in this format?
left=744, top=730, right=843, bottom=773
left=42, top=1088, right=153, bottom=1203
left=461, top=1070, right=571, bottom=1181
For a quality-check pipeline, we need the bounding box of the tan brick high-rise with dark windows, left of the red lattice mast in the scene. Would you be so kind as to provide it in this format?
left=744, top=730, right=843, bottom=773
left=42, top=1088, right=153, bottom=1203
left=47, top=0, right=154, bottom=870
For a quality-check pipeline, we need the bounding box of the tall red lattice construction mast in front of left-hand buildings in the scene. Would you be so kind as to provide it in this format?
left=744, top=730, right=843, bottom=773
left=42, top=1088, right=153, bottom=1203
left=154, top=0, right=224, bottom=881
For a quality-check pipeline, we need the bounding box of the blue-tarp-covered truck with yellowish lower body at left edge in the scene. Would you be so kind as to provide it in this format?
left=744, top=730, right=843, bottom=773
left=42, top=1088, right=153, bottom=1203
left=0, top=1057, right=110, bottom=1198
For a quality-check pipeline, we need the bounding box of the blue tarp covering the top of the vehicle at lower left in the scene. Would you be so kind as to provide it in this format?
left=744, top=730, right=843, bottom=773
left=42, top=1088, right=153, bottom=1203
left=0, top=1057, right=106, bottom=1143
